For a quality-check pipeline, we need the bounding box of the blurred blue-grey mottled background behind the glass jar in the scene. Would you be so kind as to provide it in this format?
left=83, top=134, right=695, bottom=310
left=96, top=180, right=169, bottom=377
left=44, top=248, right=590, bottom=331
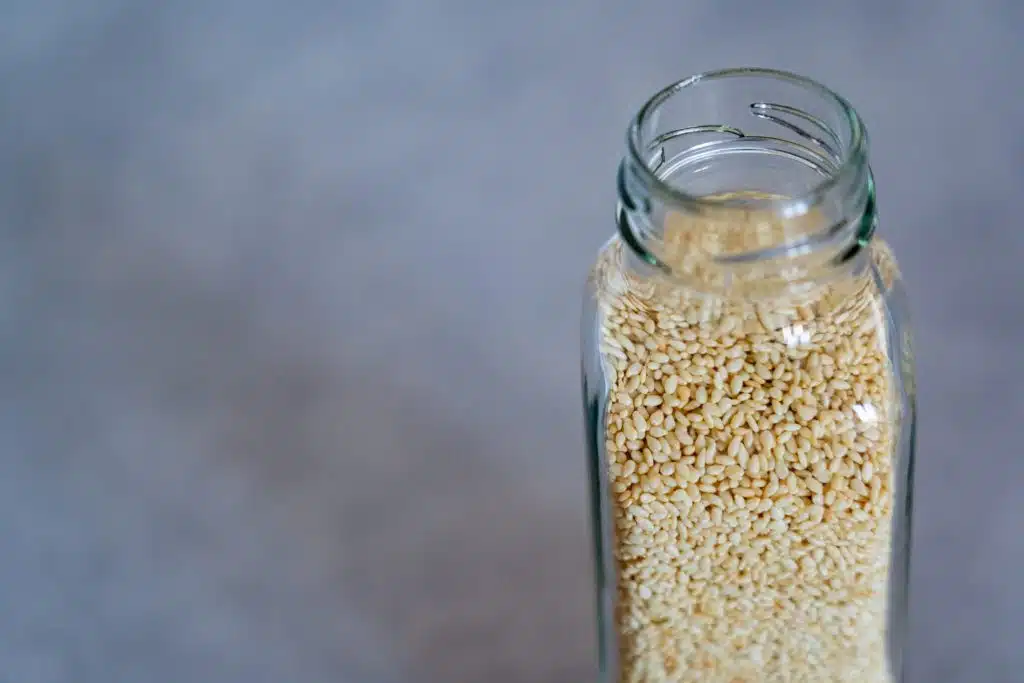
left=0, top=0, right=1024, bottom=683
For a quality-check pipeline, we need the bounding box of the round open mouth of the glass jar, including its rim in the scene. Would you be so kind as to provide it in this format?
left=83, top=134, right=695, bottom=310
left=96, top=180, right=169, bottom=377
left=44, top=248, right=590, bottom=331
left=627, top=68, right=867, bottom=215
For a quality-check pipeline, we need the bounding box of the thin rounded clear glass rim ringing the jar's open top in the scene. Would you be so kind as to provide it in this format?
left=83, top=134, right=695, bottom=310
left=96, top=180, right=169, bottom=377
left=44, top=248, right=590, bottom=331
left=626, top=67, right=867, bottom=213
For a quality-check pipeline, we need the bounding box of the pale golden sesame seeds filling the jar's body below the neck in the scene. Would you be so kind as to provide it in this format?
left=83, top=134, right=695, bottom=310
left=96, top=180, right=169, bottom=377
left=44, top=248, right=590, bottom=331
left=595, top=231, right=896, bottom=683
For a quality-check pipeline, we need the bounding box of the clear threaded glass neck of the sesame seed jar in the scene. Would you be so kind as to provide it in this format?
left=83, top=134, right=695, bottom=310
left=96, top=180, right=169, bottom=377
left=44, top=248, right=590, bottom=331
left=617, top=70, right=876, bottom=298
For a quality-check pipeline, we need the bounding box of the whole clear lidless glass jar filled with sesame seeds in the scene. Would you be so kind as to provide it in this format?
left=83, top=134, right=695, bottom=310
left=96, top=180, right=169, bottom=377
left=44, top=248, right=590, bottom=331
left=583, top=69, right=914, bottom=683
